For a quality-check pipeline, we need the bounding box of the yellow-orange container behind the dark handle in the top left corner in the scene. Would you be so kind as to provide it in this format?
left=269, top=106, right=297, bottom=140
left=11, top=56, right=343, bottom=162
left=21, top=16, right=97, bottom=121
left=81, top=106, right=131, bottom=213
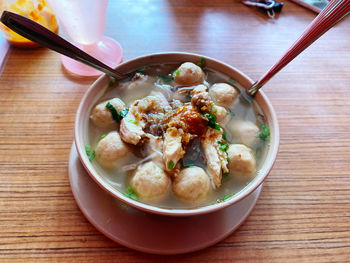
left=0, top=0, right=58, bottom=48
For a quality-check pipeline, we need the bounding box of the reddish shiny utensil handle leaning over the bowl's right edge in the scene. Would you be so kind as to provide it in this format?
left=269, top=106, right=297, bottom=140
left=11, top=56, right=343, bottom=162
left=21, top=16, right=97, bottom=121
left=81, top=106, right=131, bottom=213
left=247, top=0, right=350, bottom=97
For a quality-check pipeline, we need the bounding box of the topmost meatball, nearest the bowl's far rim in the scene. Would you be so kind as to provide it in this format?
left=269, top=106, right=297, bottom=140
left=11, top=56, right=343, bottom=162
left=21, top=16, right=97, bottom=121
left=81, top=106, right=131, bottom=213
left=173, top=62, right=205, bottom=86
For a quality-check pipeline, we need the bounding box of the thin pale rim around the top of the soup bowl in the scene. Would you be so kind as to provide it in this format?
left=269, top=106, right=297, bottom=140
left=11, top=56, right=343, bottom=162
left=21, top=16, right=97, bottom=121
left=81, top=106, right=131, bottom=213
left=74, top=52, right=279, bottom=216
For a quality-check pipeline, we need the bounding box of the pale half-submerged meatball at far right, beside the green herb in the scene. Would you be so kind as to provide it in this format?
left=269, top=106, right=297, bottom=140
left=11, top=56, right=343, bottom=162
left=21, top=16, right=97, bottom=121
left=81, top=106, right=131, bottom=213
left=228, top=120, right=259, bottom=147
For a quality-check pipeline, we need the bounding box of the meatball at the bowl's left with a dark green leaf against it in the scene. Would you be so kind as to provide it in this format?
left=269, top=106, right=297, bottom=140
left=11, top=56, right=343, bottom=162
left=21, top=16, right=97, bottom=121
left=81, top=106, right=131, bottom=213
left=90, top=98, right=125, bottom=128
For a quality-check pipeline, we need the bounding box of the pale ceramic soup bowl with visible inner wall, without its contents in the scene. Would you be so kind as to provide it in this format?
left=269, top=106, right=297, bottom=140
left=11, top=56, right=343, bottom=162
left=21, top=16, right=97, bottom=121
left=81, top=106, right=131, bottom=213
left=75, top=52, right=279, bottom=216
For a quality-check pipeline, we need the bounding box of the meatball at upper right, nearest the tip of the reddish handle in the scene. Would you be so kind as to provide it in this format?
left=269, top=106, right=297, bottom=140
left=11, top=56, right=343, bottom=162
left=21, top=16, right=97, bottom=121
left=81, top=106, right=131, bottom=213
left=209, top=83, right=238, bottom=107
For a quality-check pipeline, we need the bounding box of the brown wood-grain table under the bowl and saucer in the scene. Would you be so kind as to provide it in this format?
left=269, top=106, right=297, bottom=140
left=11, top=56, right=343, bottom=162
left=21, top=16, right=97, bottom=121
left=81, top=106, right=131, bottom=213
left=0, top=0, right=350, bottom=263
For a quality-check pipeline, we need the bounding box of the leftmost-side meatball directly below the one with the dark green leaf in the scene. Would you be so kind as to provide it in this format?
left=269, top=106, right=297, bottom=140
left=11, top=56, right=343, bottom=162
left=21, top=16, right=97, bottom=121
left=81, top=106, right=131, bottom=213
left=95, top=131, right=129, bottom=168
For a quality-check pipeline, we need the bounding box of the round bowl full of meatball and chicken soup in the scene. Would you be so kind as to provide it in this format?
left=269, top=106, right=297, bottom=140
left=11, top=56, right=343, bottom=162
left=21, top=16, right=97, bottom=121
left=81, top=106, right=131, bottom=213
left=75, top=52, right=279, bottom=216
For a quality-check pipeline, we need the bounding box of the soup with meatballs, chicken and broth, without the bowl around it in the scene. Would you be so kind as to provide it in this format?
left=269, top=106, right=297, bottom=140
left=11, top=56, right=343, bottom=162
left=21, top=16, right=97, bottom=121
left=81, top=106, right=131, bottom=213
left=86, top=59, right=269, bottom=209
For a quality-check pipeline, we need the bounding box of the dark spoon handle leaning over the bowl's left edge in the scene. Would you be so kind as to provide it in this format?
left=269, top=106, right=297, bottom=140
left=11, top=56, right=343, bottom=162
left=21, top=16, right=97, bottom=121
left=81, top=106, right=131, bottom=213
left=0, top=11, right=125, bottom=79
